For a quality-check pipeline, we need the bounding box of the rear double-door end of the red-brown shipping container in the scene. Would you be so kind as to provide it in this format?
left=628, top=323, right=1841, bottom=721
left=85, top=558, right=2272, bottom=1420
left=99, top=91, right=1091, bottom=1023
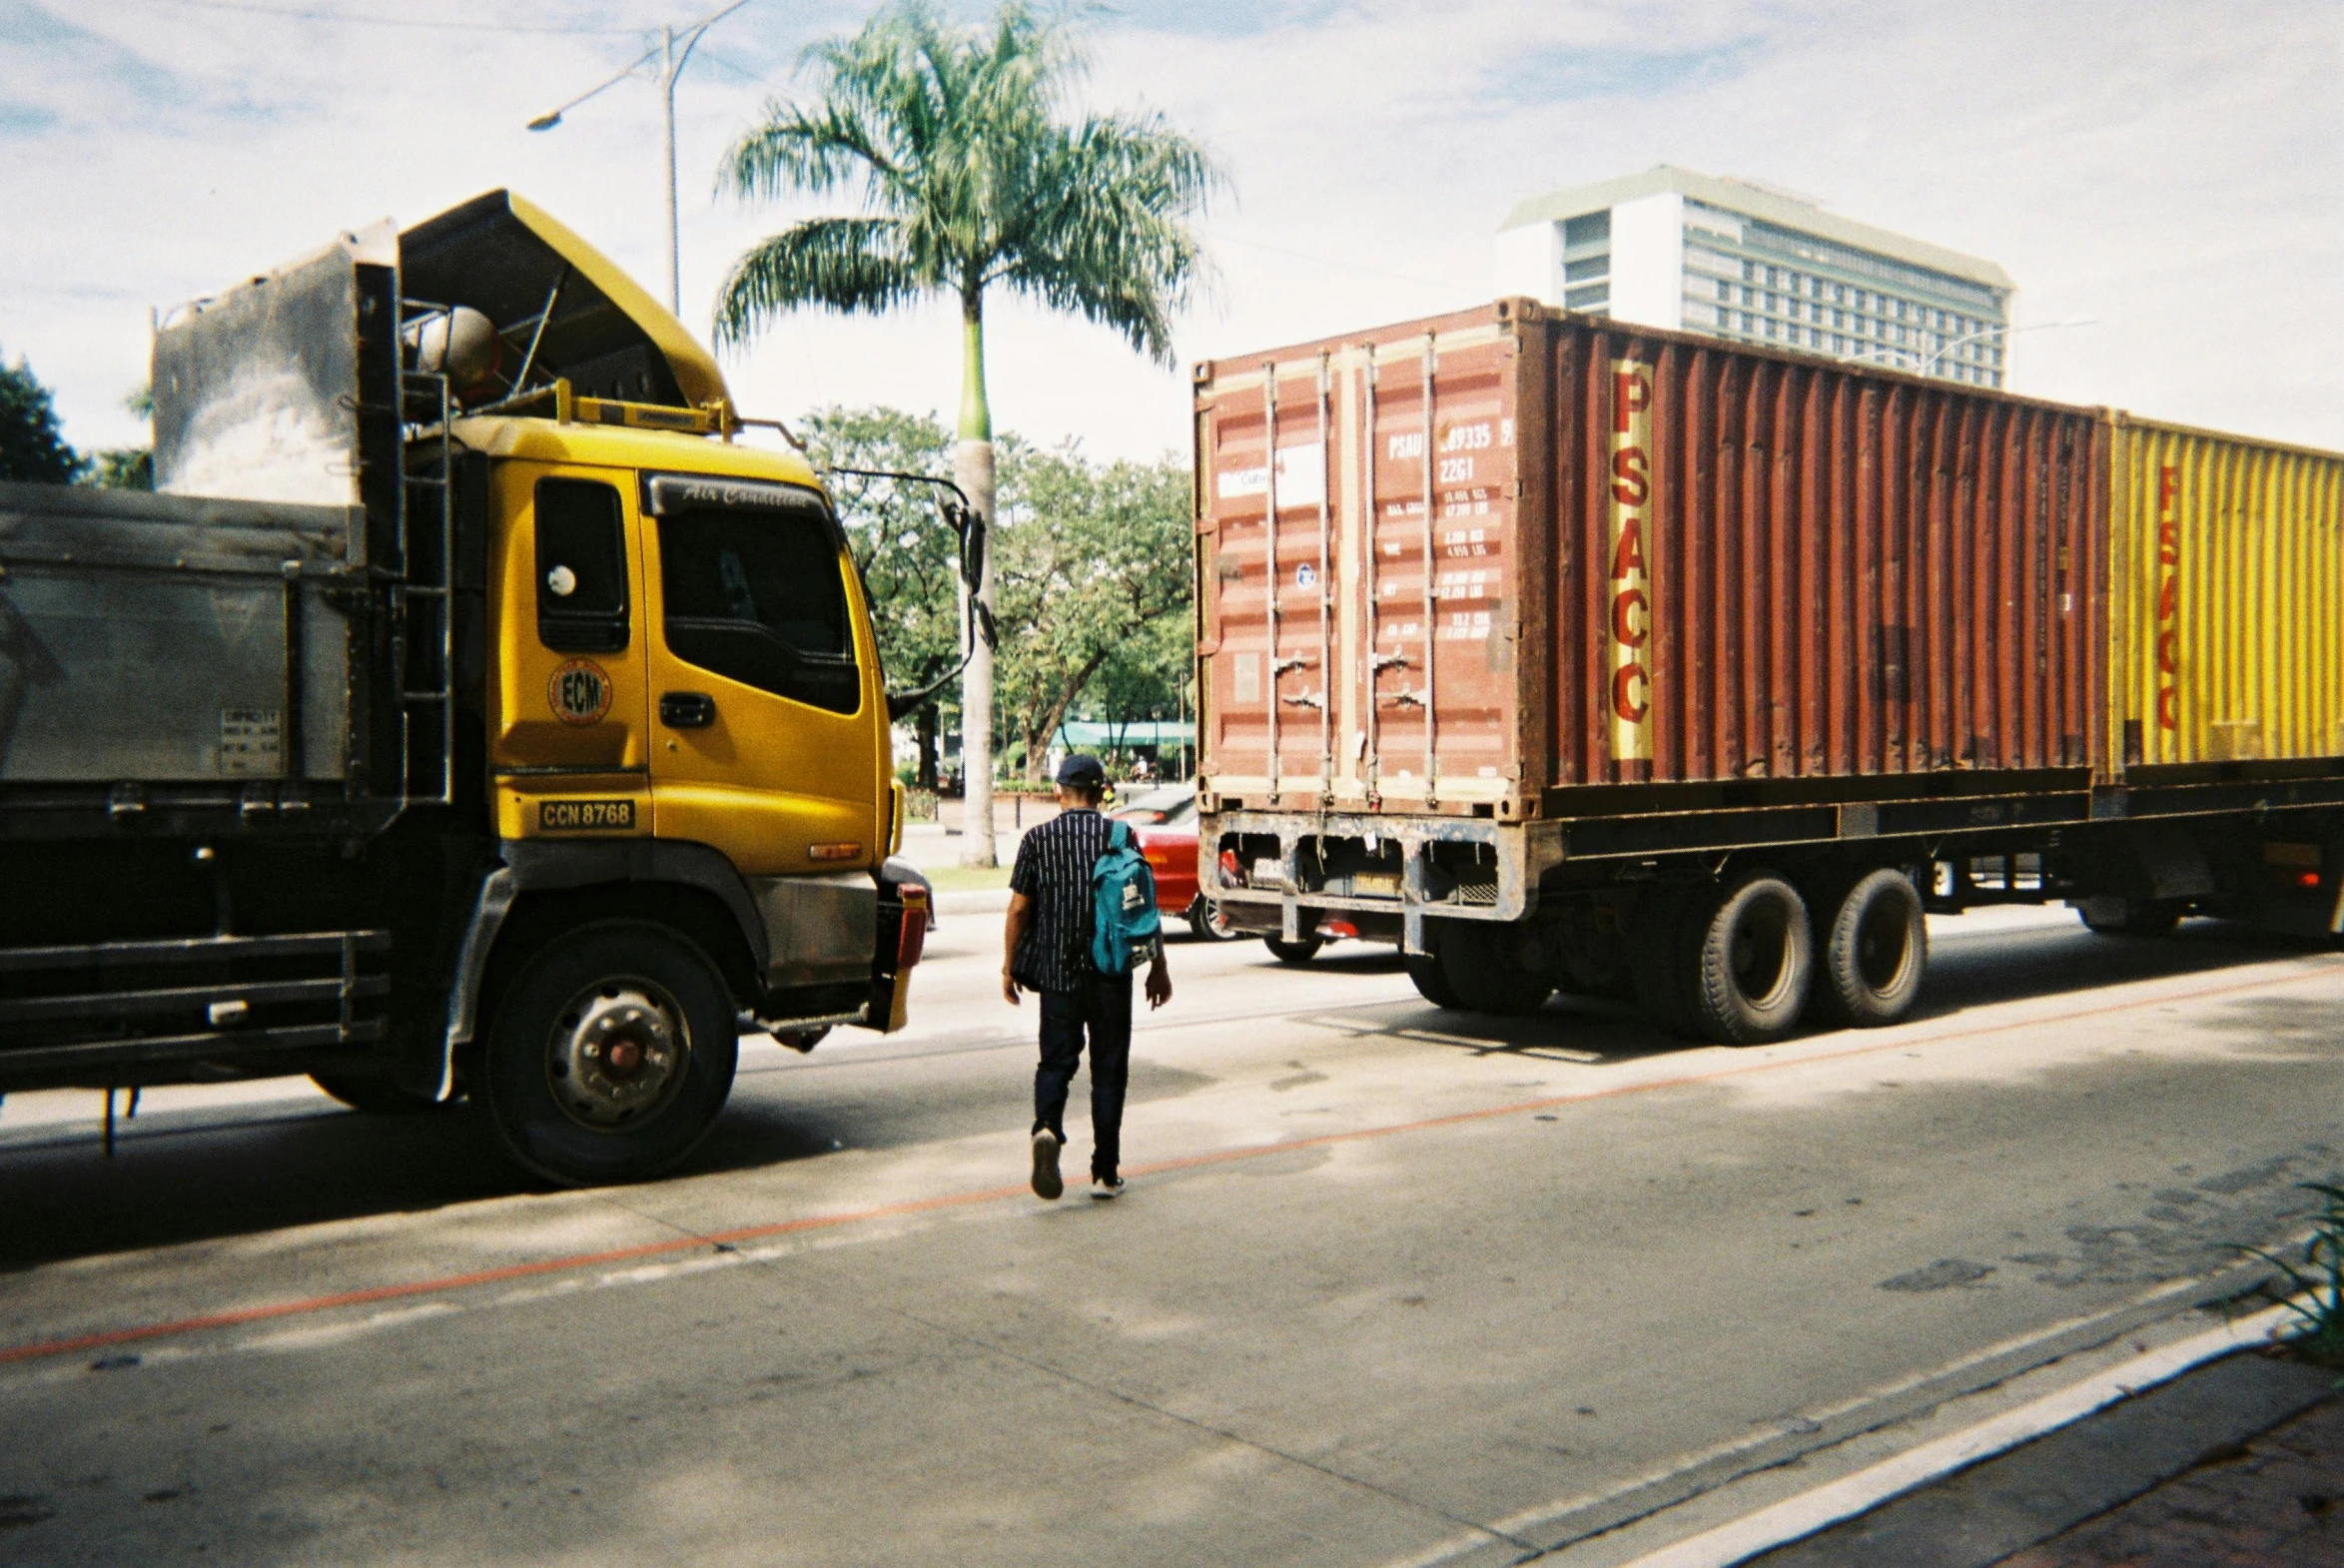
left=1195, top=307, right=1547, bottom=816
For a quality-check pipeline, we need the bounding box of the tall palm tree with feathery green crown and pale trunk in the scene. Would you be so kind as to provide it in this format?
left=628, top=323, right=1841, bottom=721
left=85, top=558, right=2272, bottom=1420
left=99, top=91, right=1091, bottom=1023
left=717, top=0, right=1221, bottom=865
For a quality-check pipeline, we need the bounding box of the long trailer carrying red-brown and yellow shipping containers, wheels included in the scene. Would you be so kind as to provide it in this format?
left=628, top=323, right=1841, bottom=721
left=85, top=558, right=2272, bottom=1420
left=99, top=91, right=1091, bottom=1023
left=1193, top=300, right=2344, bottom=1046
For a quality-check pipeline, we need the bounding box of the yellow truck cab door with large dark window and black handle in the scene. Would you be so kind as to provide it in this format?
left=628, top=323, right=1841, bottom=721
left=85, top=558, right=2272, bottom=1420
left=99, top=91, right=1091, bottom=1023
left=642, top=473, right=884, bottom=877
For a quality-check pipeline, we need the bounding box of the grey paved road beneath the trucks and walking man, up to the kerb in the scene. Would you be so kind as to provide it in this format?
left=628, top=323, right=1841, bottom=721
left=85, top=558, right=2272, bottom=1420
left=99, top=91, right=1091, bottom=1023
left=0, top=914, right=2344, bottom=1566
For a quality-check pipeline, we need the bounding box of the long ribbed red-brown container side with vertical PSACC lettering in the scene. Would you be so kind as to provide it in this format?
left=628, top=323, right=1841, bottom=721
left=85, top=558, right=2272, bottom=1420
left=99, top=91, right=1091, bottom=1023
left=1552, top=319, right=2105, bottom=785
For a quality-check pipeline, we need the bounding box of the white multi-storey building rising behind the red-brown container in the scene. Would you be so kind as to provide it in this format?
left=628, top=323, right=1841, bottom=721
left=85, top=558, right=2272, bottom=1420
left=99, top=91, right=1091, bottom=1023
left=1498, top=164, right=2013, bottom=387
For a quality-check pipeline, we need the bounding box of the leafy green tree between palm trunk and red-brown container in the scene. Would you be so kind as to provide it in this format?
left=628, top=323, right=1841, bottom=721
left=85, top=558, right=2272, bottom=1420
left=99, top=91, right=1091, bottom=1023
left=999, top=443, right=1193, bottom=783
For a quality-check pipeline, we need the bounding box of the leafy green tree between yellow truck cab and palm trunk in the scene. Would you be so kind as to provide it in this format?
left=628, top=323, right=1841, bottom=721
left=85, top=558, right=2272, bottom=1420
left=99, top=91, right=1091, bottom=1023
left=797, top=407, right=961, bottom=790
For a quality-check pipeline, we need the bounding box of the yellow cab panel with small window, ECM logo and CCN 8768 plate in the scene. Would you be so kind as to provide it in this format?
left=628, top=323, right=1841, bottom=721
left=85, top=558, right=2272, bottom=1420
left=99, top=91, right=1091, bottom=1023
left=494, top=464, right=649, bottom=837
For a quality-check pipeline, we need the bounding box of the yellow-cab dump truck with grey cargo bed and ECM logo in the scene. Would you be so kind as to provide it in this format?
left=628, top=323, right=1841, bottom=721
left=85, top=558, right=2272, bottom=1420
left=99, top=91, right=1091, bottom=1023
left=0, top=190, right=982, bottom=1181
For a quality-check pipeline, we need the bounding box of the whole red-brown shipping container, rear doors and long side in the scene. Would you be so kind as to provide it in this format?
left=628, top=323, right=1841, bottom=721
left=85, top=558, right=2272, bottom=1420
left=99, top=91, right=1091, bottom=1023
left=1195, top=300, right=2107, bottom=820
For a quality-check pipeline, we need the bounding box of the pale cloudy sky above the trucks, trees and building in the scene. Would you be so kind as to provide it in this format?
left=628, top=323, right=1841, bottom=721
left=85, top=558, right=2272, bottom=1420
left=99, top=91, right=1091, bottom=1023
left=0, top=0, right=2344, bottom=457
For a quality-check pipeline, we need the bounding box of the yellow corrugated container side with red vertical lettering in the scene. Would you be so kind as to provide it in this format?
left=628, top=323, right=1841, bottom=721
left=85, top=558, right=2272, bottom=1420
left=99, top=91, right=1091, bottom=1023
left=2109, top=417, right=2344, bottom=769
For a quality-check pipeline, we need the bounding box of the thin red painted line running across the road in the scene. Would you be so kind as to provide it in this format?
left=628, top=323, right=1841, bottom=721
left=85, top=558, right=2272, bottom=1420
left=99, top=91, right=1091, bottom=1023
left=0, top=959, right=2344, bottom=1366
